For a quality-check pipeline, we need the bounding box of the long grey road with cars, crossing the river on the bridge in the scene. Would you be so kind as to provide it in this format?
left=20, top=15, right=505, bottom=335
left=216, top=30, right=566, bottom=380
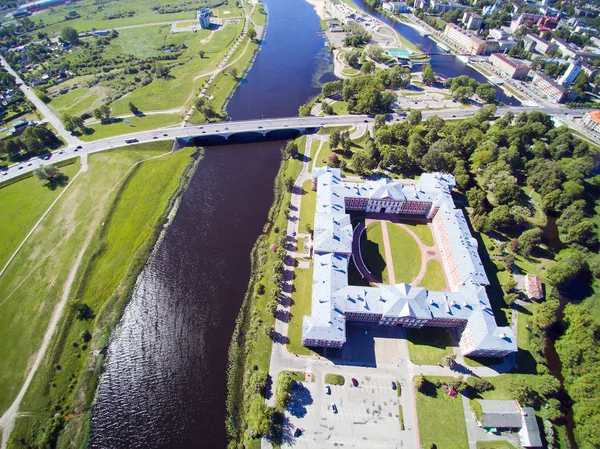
left=0, top=105, right=588, bottom=182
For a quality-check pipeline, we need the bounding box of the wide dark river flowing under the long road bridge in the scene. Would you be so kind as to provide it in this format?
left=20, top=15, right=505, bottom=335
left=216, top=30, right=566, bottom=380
left=90, top=0, right=334, bottom=449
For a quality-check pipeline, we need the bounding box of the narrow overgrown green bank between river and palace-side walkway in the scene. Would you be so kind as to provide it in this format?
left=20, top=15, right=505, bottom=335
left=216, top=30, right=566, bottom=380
left=226, top=136, right=306, bottom=448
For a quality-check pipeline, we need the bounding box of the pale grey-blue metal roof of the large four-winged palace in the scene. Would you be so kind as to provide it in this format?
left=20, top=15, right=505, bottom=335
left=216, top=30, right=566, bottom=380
left=302, top=167, right=516, bottom=352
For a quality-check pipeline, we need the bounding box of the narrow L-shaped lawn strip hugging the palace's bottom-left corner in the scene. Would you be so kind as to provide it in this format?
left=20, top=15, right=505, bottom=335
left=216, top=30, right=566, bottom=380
left=287, top=267, right=315, bottom=355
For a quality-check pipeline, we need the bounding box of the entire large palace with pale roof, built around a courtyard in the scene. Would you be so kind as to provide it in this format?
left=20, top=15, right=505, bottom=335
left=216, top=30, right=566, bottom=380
left=302, top=167, right=517, bottom=357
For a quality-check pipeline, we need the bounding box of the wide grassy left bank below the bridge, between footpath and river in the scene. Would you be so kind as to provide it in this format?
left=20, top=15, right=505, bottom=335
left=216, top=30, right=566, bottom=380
left=0, top=142, right=196, bottom=448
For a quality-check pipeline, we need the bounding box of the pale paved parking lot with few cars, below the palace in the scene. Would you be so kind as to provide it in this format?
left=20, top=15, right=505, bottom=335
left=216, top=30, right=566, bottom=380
left=284, top=368, right=410, bottom=448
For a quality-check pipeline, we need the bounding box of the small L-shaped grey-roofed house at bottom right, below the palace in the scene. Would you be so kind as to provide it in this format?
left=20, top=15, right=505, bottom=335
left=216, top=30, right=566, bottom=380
left=479, top=399, right=542, bottom=448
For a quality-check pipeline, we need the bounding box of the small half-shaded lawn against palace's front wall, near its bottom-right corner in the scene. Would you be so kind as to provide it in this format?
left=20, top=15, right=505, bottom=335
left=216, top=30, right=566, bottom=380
left=406, top=327, right=452, bottom=365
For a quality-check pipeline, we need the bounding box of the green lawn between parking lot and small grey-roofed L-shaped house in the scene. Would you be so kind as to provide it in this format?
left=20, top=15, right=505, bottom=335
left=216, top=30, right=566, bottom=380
left=416, top=377, right=469, bottom=449
